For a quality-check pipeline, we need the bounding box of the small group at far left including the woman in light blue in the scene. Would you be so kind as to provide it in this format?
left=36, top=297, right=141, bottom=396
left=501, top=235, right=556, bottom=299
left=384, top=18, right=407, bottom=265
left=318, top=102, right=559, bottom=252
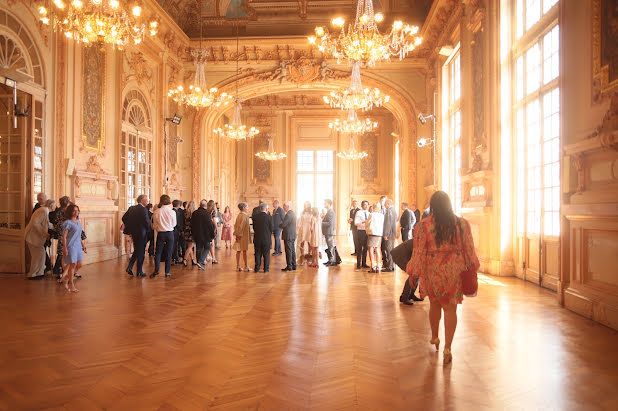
left=25, top=193, right=86, bottom=292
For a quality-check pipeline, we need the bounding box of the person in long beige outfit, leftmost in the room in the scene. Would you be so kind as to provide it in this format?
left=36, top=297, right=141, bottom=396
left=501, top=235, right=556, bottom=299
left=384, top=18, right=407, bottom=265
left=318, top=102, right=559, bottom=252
left=26, top=200, right=56, bottom=280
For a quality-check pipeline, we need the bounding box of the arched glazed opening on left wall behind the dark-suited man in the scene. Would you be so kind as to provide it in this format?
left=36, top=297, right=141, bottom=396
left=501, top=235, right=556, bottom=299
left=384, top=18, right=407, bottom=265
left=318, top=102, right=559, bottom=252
left=120, top=90, right=152, bottom=210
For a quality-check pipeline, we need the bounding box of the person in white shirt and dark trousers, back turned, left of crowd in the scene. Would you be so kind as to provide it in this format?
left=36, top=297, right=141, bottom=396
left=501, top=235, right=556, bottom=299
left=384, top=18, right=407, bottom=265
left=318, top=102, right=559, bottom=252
left=150, top=194, right=176, bottom=278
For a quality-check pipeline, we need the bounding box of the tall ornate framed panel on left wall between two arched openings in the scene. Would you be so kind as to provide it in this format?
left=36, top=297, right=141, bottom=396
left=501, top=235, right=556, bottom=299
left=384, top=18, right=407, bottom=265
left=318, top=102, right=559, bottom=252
left=82, top=47, right=105, bottom=151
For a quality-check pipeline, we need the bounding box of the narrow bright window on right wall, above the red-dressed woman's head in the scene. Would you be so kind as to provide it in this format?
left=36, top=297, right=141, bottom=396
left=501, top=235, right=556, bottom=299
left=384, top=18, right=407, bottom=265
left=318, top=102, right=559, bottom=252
left=442, top=45, right=462, bottom=212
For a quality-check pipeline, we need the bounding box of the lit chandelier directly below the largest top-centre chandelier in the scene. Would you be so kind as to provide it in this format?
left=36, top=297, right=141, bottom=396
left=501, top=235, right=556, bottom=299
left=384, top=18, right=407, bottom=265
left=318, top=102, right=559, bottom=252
left=324, top=62, right=390, bottom=111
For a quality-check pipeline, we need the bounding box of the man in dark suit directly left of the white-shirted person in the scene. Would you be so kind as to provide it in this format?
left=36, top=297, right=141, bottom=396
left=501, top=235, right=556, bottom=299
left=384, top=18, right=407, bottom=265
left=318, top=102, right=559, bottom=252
left=122, top=194, right=150, bottom=277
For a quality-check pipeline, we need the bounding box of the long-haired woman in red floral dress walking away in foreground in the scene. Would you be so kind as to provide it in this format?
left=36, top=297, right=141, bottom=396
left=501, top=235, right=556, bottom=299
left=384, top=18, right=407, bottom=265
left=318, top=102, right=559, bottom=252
left=406, top=191, right=479, bottom=363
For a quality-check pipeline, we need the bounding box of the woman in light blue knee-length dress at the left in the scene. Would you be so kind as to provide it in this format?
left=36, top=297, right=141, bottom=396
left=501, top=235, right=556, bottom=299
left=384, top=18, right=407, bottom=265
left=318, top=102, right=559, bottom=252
left=62, top=203, right=86, bottom=293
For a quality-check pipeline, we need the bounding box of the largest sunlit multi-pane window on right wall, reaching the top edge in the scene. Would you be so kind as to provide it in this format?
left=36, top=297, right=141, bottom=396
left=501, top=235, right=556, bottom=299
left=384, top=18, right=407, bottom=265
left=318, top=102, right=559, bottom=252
left=513, top=0, right=560, bottom=237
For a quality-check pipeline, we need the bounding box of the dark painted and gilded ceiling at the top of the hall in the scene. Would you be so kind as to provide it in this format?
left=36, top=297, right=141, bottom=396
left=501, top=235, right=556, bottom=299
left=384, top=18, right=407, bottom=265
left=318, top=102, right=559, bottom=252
left=157, top=0, right=432, bottom=38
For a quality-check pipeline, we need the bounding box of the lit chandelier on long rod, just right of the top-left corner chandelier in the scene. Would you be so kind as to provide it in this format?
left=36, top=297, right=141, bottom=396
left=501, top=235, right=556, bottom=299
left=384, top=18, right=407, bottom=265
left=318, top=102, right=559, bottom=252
left=167, top=2, right=232, bottom=109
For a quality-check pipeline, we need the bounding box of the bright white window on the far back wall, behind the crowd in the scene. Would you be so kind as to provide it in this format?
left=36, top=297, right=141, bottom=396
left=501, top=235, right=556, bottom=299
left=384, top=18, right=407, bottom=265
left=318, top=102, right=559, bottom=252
left=296, top=150, right=335, bottom=210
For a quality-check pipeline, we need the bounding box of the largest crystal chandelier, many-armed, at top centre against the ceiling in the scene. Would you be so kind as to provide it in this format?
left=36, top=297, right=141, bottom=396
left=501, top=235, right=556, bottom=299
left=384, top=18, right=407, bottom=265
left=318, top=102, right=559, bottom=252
left=309, top=0, right=423, bottom=66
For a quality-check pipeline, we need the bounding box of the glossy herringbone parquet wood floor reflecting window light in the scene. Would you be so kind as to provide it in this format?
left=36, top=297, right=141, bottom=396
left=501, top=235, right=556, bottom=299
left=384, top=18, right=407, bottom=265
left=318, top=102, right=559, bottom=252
left=0, top=240, right=618, bottom=410
